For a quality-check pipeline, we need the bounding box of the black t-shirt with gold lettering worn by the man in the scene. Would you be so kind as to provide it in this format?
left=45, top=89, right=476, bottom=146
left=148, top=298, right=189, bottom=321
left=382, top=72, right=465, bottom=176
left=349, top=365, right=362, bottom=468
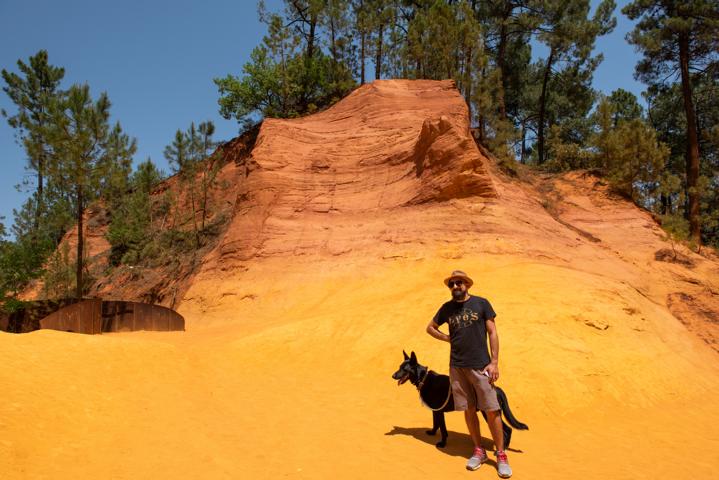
left=434, top=295, right=496, bottom=369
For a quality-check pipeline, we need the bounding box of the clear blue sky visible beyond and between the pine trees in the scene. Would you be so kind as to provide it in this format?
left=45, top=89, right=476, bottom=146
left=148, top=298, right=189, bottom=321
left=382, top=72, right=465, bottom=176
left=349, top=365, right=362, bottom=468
left=0, top=0, right=643, bottom=235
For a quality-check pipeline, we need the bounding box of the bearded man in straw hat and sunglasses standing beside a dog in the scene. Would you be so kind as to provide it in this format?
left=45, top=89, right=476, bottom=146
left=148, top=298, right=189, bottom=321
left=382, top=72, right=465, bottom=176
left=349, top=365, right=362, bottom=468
left=427, top=270, right=512, bottom=478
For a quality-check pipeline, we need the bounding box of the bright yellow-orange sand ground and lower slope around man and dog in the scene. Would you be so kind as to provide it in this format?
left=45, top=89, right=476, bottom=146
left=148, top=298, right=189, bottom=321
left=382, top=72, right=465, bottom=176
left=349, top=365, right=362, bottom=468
left=0, top=253, right=719, bottom=479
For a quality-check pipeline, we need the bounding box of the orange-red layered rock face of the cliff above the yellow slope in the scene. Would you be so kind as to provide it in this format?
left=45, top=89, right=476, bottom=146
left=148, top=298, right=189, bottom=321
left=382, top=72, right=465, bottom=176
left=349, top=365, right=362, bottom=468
left=216, top=80, right=496, bottom=260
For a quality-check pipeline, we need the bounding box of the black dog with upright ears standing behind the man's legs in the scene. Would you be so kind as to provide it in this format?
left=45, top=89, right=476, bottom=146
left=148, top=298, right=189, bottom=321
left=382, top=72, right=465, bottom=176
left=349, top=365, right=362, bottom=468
left=392, top=351, right=529, bottom=448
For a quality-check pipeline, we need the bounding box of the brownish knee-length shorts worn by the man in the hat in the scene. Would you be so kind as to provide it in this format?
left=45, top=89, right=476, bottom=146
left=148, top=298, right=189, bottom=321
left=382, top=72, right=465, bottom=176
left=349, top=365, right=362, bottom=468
left=449, top=367, right=499, bottom=412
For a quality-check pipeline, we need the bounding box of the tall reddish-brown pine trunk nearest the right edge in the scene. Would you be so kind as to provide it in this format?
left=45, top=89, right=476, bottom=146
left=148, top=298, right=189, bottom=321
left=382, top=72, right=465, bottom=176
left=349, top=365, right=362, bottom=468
left=679, top=33, right=701, bottom=245
